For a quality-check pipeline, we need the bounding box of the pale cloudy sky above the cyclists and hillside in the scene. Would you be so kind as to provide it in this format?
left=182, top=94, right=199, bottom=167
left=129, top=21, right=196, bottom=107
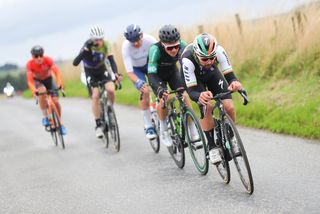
left=0, top=0, right=312, bottom=66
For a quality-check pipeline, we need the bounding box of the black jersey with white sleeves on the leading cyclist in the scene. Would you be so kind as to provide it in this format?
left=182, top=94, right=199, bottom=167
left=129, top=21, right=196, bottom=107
left=181, top=44, right=237, bottom=101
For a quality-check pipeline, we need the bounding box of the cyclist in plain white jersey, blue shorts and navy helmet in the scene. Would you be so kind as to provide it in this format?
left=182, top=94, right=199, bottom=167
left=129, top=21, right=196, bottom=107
left=122, top=24, right=157, bottom=139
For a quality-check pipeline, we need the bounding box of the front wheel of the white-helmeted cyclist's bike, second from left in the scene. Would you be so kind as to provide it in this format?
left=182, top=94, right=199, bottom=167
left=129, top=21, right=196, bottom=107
left=108, top=105, right=120, bottom=152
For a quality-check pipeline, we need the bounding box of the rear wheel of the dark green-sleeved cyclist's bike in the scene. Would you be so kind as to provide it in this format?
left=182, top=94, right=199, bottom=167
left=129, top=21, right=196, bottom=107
left=168, top=99, right=185, bottom=169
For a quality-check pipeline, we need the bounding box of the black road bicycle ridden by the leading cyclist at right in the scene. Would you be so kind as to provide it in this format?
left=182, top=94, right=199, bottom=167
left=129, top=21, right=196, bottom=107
left=200, top=90, right=254, bottom=194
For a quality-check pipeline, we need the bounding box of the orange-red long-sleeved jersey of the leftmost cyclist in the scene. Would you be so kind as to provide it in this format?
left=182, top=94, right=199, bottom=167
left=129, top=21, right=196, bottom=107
left=26, top=56, right=62, bottom=93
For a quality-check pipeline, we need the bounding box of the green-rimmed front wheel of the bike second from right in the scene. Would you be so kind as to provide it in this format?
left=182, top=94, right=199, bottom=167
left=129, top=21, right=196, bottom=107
left=183, top=108, right=209, bottom=175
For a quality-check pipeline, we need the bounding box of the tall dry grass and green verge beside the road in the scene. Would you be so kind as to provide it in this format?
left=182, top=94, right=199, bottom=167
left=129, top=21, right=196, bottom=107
left=23, top=5, right=320, bottom=139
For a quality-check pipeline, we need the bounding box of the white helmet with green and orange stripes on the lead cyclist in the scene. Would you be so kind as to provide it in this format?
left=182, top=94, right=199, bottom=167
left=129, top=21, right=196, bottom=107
left=192, top=33, right=218, bottom=58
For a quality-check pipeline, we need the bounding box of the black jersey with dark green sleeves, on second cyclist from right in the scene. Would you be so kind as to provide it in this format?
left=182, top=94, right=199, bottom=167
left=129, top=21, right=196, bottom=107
left=148, top=40, right=186, bottom=94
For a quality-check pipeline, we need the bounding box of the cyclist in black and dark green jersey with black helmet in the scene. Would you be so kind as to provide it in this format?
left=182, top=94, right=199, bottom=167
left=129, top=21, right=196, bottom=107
left=148, top=25, right=198, bottom=147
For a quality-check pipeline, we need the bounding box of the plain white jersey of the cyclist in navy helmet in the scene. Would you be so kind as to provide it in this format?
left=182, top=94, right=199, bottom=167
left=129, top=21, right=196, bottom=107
left=122, top=34, right=157, bottom=73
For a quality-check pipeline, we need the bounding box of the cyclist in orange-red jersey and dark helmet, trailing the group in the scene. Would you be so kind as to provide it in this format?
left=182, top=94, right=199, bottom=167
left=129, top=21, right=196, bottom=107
left=26, top=45, right=67, bottom=135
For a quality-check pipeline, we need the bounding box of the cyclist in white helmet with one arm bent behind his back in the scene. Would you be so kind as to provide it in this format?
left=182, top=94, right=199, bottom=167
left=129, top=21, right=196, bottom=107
left=73, top=26, right=121, bottom=138
